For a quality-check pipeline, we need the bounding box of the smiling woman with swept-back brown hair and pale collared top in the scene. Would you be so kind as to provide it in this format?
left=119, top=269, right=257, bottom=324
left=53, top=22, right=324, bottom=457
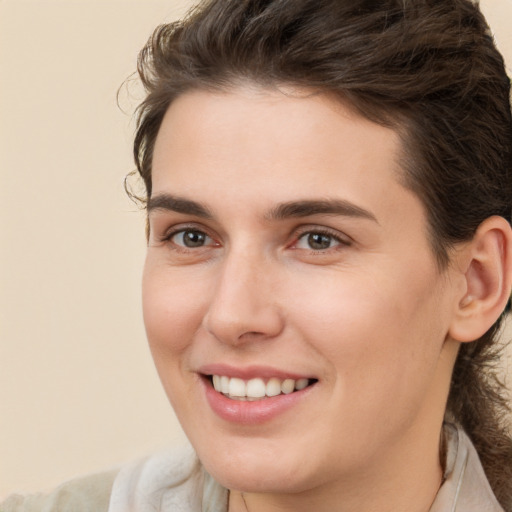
left=2, top=0, right=512, bottom=512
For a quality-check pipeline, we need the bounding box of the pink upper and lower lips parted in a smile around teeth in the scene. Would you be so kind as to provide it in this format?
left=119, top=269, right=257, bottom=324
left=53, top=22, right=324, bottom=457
left=200, top=364, right=318, bottom=426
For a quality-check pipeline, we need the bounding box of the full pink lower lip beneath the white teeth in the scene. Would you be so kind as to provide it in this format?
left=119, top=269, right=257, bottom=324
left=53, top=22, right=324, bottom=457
left=201, top=379, right=316, bottom=425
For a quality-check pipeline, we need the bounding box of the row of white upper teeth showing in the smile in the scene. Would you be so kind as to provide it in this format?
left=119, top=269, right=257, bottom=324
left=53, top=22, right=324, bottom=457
left=212, top=375, right=310, bottom=401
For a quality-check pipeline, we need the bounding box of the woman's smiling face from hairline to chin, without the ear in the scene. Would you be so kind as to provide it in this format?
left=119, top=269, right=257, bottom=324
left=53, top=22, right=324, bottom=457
left=143, top=87, right=455, bottom=492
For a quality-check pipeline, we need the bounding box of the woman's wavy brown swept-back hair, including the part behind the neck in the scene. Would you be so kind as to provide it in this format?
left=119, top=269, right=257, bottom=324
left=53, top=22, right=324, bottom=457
left=134, top=0, right=512, bottom=512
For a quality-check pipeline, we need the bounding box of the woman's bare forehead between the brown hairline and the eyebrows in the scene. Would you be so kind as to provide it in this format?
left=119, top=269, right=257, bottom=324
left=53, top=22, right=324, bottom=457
left=152, top=87, right=420, bottom=231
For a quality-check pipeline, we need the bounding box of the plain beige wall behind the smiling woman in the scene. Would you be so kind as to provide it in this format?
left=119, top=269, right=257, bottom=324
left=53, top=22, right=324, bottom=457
left=0, top=0, right=512, bottom=496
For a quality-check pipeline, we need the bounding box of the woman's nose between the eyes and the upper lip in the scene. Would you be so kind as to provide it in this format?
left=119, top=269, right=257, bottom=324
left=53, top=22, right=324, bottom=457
left=203, top=247, right=284, bottom=345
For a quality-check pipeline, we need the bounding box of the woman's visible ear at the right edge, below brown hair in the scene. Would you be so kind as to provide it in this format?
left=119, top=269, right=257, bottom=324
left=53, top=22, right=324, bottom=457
left=449, top=216, right=512, bottom=342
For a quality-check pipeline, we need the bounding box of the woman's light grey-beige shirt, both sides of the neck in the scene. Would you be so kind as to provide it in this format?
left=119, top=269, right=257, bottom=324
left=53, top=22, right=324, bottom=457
left=0, top=425, right=504, bottom=512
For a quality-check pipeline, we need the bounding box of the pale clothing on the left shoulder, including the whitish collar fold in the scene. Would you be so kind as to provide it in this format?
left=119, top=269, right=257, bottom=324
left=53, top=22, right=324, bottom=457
left=0, top=445, right=228, bottom=512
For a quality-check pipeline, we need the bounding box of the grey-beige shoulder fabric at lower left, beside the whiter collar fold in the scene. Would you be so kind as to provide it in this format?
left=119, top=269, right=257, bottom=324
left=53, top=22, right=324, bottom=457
left=0, top=470, right=118, bottom=512
